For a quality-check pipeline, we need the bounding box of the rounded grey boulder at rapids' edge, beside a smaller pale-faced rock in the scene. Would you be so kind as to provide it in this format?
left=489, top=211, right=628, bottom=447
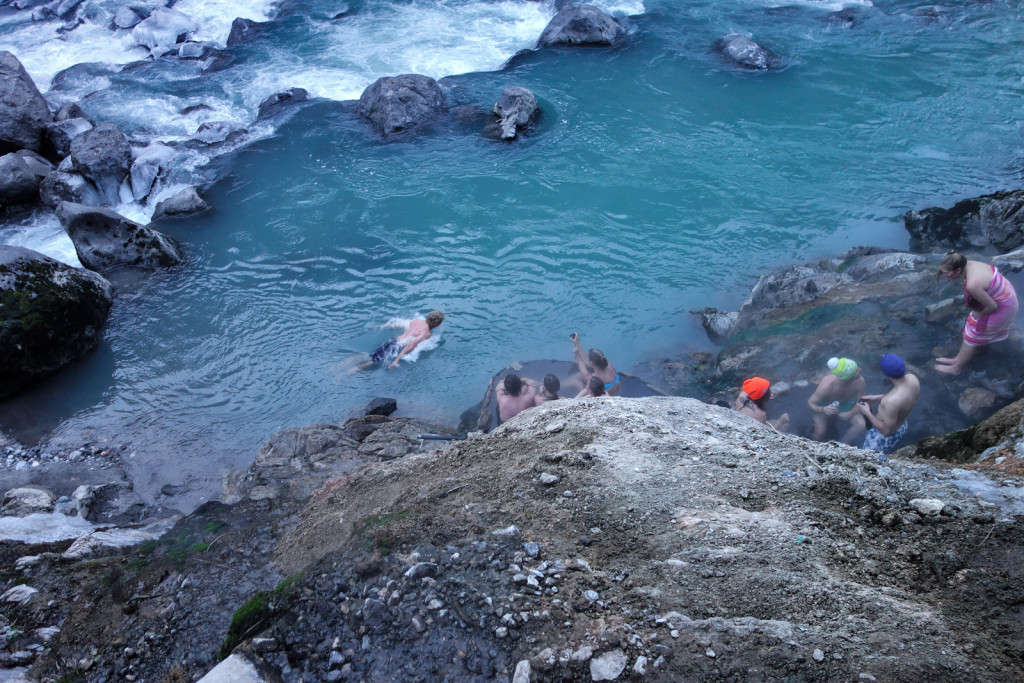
left=359, top=74, right=446, bottom=137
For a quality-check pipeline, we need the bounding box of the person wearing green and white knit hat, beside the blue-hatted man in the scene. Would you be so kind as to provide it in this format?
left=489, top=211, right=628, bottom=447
left=807, top=358, right=867, bottom=445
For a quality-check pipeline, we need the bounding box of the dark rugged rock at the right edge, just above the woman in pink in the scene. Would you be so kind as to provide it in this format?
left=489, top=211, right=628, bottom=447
left=903, top=189, right=1024, bottom=252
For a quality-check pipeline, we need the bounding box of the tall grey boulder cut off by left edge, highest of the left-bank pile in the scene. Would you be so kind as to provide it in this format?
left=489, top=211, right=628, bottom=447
left=0, top=50, right=50, bottom=154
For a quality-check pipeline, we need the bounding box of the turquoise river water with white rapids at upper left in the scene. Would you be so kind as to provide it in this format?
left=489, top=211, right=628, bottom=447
left=0, top=0, right=1024, bottom=501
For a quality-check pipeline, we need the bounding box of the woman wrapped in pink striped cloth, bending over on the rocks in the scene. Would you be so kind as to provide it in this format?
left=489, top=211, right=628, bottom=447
left=935, top=251, right=1017, bottom=375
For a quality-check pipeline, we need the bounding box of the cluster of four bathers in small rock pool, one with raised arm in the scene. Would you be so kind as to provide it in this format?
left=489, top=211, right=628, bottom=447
left=495, top=332, right=623, bottom=422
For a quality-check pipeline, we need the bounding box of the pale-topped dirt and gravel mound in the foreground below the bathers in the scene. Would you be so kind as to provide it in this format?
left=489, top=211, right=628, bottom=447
left=269, top=398, right=1022, bottom=680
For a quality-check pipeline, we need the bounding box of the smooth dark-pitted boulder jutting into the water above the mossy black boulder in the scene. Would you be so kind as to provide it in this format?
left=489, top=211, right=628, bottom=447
left=57, top=202, right=181, bottom=272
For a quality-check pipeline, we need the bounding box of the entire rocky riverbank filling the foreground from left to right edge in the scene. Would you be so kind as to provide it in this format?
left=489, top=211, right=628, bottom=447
left=0, top=397, right=1024, bottom=681
